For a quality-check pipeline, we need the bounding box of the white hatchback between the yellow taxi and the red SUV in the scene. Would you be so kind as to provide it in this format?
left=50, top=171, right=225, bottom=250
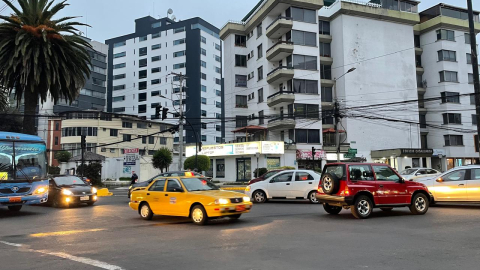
left=245, top=170, right=320, bottom=203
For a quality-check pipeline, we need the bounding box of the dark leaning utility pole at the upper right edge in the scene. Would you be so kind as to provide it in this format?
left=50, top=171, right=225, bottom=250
left=467, top=0, right=480, bottom=160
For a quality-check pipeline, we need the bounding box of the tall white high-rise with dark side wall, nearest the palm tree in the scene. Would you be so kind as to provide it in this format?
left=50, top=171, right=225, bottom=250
left=106, top=16, right=222, bottom=148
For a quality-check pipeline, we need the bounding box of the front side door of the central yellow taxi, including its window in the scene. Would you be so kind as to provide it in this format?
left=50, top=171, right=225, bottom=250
left=165, top=179, right=190, bottom=217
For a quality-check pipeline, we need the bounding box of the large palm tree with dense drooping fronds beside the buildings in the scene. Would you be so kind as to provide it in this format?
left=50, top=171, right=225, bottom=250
left=0, top=0, right=91, bottom=134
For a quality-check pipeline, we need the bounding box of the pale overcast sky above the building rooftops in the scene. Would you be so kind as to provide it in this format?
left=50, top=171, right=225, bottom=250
left=0, top=0, right=480, bottom=42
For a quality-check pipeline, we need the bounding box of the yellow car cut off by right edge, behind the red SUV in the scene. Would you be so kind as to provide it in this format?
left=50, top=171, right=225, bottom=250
left=416, top=165, right=480, bottom=202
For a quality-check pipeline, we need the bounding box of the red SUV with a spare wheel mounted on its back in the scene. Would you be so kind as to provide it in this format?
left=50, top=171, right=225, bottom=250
left=317, top=163, right=431, bottom=218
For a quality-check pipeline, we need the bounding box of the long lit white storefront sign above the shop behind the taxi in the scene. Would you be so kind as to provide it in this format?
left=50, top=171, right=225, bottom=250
left=185, top=141, right=284, bottom=157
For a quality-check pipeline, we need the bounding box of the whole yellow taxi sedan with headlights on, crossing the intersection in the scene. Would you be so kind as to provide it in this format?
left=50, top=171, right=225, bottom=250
left=129, top=176, right=252, bottom=225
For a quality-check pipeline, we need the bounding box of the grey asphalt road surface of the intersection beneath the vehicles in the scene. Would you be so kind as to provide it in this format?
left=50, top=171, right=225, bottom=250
left=0, top=191, right=480, bottom=270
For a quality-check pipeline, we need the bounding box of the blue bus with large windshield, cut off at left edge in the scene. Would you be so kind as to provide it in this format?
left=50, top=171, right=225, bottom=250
left=0, top=131, right=48, bottom=211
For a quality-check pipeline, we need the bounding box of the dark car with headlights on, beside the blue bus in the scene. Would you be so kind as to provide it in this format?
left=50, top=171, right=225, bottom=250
left=47, top=175, right=97, bottom=207
